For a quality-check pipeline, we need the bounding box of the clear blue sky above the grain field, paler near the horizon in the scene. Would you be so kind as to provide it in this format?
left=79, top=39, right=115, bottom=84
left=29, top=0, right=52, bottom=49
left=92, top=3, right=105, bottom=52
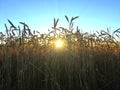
left=0, top=0, right=120, bottom=33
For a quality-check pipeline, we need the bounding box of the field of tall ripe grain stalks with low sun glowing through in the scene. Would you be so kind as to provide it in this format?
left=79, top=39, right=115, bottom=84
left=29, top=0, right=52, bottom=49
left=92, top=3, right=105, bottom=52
left=0, top=16, right=120, bottom=90
